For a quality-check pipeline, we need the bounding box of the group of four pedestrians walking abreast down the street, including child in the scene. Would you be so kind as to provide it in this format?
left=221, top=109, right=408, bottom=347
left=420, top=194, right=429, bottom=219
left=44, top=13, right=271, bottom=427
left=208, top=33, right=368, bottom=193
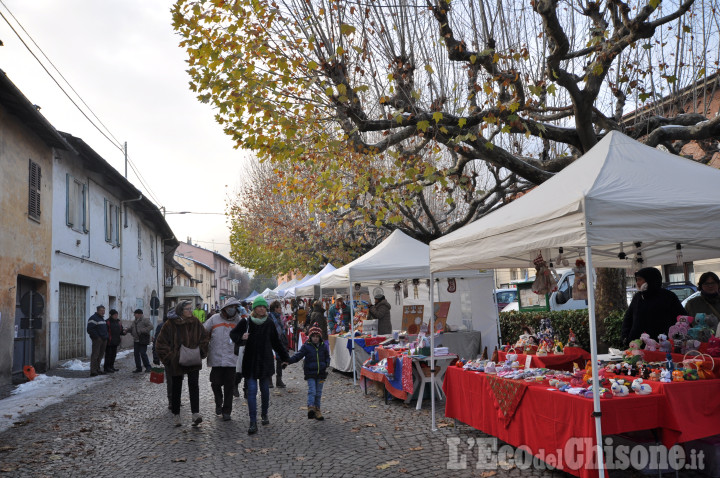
left=155, top=296, right=330, bottom=434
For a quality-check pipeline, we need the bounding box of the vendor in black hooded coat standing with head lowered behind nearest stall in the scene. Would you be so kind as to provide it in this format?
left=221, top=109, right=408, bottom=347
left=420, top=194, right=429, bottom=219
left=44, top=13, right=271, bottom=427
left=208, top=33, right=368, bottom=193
left=621, top=267, right=687, bottom=347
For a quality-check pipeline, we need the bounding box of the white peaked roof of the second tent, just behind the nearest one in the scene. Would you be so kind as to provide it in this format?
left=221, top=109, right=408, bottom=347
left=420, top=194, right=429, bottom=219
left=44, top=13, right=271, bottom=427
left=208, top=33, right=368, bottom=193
left=320, top=230, right=430, bottom=289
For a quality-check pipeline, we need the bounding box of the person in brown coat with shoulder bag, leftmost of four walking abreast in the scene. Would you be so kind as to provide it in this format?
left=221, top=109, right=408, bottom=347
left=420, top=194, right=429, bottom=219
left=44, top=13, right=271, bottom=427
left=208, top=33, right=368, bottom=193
left=157, top=300, right=209, bottom=427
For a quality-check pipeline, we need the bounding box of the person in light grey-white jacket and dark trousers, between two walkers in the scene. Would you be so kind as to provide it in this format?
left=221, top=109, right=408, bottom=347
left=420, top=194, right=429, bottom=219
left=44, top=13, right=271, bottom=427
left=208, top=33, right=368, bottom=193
left=203, top=299, right=244, bottom=421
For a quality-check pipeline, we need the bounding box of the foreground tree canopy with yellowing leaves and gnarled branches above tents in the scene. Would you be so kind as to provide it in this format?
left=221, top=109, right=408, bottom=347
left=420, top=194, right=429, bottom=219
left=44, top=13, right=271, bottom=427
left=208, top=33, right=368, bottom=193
left=173, top=0, right=720, bottom=274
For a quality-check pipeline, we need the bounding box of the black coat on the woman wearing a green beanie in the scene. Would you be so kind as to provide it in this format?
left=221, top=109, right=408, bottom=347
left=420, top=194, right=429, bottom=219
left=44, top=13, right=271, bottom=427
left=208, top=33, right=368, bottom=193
left=230, top=312, right=290, bottom=379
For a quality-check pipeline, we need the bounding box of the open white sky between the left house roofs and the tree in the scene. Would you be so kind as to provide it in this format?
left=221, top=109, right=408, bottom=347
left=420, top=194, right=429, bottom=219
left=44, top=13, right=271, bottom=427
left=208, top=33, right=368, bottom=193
left=0, top=0, right=253, bottom=255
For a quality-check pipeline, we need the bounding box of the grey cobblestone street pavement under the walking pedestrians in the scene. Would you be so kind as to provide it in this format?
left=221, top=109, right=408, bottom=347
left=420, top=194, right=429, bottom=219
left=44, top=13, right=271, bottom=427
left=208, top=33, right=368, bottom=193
left=0, top=356, right=708, bottom=478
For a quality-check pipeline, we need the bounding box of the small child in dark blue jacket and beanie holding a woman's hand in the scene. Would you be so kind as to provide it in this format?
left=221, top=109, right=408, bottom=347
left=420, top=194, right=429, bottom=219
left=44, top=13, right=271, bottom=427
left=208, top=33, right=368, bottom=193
left=283, top=324, right=330, bottom=420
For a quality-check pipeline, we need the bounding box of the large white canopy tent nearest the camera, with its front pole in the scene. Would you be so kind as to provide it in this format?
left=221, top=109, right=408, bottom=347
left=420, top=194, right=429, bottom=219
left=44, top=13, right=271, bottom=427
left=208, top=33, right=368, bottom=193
left=430, top=132, right=720, bottom=476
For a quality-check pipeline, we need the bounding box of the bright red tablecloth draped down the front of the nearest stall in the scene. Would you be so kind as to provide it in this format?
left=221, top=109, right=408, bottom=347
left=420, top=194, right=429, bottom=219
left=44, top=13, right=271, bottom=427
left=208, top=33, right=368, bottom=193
left=443, top=367, right=720, bottom=477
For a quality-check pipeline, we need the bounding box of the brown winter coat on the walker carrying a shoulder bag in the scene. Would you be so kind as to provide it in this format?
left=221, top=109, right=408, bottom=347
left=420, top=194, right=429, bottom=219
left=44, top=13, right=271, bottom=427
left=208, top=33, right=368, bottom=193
left=155, top=317, right=209, bottom=377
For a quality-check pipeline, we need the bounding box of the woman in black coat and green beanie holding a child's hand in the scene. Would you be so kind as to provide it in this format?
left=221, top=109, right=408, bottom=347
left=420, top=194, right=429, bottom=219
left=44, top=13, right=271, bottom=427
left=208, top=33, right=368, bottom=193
left=230, top=296, right=290, bottom=435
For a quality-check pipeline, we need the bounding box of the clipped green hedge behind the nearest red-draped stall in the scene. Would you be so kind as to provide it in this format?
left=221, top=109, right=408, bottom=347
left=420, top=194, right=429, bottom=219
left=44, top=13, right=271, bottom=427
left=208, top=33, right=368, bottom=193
left=500, top=309, right=625, bottom=350
